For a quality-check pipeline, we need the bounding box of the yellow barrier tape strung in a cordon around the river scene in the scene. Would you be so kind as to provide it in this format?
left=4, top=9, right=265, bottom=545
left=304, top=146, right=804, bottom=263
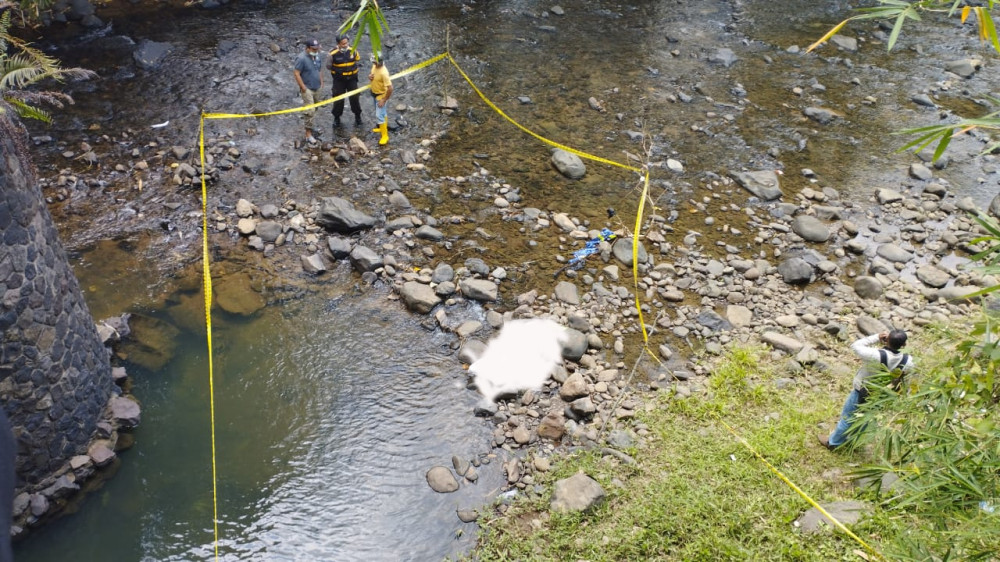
left=198, top=51, right=885, bottom=560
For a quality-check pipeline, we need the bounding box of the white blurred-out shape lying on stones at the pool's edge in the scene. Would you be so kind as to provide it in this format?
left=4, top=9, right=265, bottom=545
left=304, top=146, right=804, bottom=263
left=469, top=319, right=569, bottom=402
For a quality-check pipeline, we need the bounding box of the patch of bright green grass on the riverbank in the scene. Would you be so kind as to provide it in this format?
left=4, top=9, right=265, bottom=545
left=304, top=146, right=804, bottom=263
left=474, top=349, right=901, bottom=561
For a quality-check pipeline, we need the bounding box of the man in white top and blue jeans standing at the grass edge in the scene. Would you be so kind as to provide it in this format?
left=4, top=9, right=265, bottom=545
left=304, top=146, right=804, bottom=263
left=818, top=330, right=913, bottom=450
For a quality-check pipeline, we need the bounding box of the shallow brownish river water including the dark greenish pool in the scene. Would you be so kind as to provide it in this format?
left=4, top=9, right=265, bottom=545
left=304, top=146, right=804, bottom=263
left=11, top=0, right=996, bottom=561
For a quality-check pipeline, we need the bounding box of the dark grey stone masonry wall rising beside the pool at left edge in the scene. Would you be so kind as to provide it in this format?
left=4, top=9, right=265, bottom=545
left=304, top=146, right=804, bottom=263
left=0, top=127, right=114, bottom=490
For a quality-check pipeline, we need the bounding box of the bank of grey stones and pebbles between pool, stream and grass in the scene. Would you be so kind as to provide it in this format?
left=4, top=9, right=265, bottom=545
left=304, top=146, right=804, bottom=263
left=39, top=106, right=997, bottom=518
